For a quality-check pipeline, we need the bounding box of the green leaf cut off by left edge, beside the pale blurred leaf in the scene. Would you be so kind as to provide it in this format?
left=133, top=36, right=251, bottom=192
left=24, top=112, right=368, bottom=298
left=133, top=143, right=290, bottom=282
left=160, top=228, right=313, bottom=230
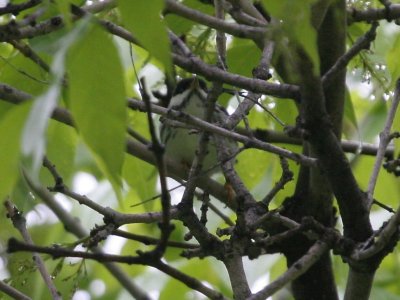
left=0, top=103, right=31, bottom=199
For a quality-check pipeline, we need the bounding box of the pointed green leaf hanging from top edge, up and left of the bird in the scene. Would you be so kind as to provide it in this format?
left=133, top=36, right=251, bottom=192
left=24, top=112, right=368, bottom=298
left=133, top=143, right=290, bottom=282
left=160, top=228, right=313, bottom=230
left=118, top=0, right=172, bottom=73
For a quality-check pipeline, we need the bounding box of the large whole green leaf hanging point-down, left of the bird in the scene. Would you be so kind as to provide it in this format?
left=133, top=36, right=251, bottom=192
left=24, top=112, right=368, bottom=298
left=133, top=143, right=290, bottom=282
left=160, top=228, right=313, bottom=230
left=68, top=25, right=126, bottom=199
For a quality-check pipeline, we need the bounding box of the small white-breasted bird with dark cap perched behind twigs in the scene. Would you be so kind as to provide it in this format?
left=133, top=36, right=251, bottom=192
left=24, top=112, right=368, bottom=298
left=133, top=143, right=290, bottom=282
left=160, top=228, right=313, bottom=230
left=160, top=76, right=237, bottom=175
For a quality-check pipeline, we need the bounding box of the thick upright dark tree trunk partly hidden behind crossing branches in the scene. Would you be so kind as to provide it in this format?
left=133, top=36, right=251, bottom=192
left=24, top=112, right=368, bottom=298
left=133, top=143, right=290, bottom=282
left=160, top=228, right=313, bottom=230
left=285, top=0, right=352, bottom=299
